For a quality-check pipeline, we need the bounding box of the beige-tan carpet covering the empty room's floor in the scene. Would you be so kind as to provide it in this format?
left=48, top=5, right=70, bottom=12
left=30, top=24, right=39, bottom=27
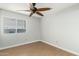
left=0, top=42, right=75, bottom=56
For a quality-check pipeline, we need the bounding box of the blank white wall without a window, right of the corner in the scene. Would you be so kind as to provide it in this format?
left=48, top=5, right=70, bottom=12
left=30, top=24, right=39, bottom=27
left=41, top=4, right=79, bottom=53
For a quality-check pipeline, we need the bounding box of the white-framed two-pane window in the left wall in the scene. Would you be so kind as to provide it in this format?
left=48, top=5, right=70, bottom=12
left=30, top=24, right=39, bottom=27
left=3, top=17, right=26, bottom=33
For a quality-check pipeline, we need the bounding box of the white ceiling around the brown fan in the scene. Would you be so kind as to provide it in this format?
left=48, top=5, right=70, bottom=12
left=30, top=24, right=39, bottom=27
left=0, top=3, right=75, bottom=15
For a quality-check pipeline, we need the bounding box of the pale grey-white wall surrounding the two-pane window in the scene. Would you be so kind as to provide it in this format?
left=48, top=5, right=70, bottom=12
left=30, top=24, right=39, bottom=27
left=0, top=10, right=40, bottom=49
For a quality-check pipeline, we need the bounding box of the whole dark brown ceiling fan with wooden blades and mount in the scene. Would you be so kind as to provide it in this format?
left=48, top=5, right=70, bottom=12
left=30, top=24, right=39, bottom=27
left=18, top=3, right=51, bottom=17
